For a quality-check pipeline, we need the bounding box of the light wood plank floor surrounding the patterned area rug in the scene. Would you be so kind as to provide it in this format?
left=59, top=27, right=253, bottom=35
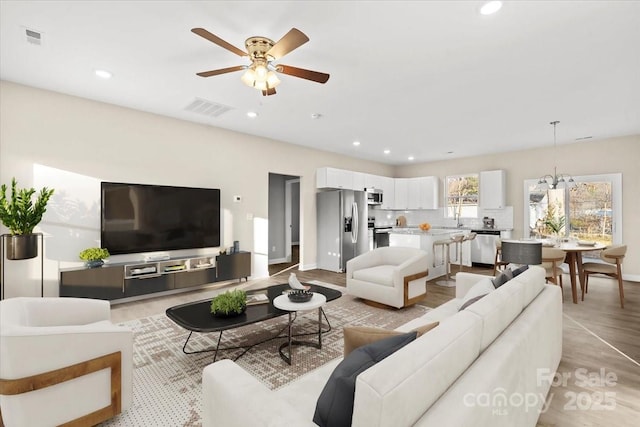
left=111, top=268, right=640, bottom=427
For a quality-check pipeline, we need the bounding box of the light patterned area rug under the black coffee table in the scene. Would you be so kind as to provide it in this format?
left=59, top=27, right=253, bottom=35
left=101, top=282, right=429, bottom=427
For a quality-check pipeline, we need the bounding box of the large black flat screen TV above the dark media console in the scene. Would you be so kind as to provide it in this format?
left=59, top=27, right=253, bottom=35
left=100, top=182, right=220, bottom=255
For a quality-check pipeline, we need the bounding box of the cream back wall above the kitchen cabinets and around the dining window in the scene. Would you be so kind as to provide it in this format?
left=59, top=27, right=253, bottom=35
left=395, top=135, right=640, bottom=281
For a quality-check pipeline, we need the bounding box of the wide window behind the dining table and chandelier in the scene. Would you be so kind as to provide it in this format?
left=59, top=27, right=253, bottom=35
left=524, top=174, right=622, bottom=245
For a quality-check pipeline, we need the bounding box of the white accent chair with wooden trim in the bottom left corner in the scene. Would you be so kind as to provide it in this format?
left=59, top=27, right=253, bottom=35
left=0, top=298, right=133, bottom=427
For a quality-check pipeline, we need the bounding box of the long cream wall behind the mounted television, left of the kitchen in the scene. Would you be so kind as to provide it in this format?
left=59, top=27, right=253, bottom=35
left=0, top=81, right=393, bottom=297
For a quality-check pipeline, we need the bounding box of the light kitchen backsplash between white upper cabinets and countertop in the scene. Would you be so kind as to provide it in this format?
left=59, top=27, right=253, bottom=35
left=369, top=206, right=513, bottom=230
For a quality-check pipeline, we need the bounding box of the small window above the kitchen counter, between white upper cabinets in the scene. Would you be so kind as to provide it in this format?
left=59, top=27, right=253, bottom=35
left=445, top=174, right=478, bottom=218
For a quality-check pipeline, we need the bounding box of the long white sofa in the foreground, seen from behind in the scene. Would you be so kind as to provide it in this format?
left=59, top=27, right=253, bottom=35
left=203, top=267, right=562, bottom=427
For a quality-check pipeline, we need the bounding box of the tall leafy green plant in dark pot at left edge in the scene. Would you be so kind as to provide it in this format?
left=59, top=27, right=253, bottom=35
left=0, top=178, right=54, bottom=260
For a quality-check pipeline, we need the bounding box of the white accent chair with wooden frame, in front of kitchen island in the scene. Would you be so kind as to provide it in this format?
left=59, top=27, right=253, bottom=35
left=347, top=246, right=429, bottom=308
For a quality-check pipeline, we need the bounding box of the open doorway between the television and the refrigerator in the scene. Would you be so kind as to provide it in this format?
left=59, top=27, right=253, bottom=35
left=269, top=173, right=300, bottom=276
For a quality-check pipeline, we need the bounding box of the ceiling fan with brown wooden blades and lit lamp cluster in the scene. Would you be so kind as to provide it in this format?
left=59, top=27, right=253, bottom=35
left=191, top=28, right=329, bottom=96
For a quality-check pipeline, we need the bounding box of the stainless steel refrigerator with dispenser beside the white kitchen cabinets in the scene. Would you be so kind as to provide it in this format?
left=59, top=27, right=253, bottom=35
left=316, top=190, right=369, bottom=273
